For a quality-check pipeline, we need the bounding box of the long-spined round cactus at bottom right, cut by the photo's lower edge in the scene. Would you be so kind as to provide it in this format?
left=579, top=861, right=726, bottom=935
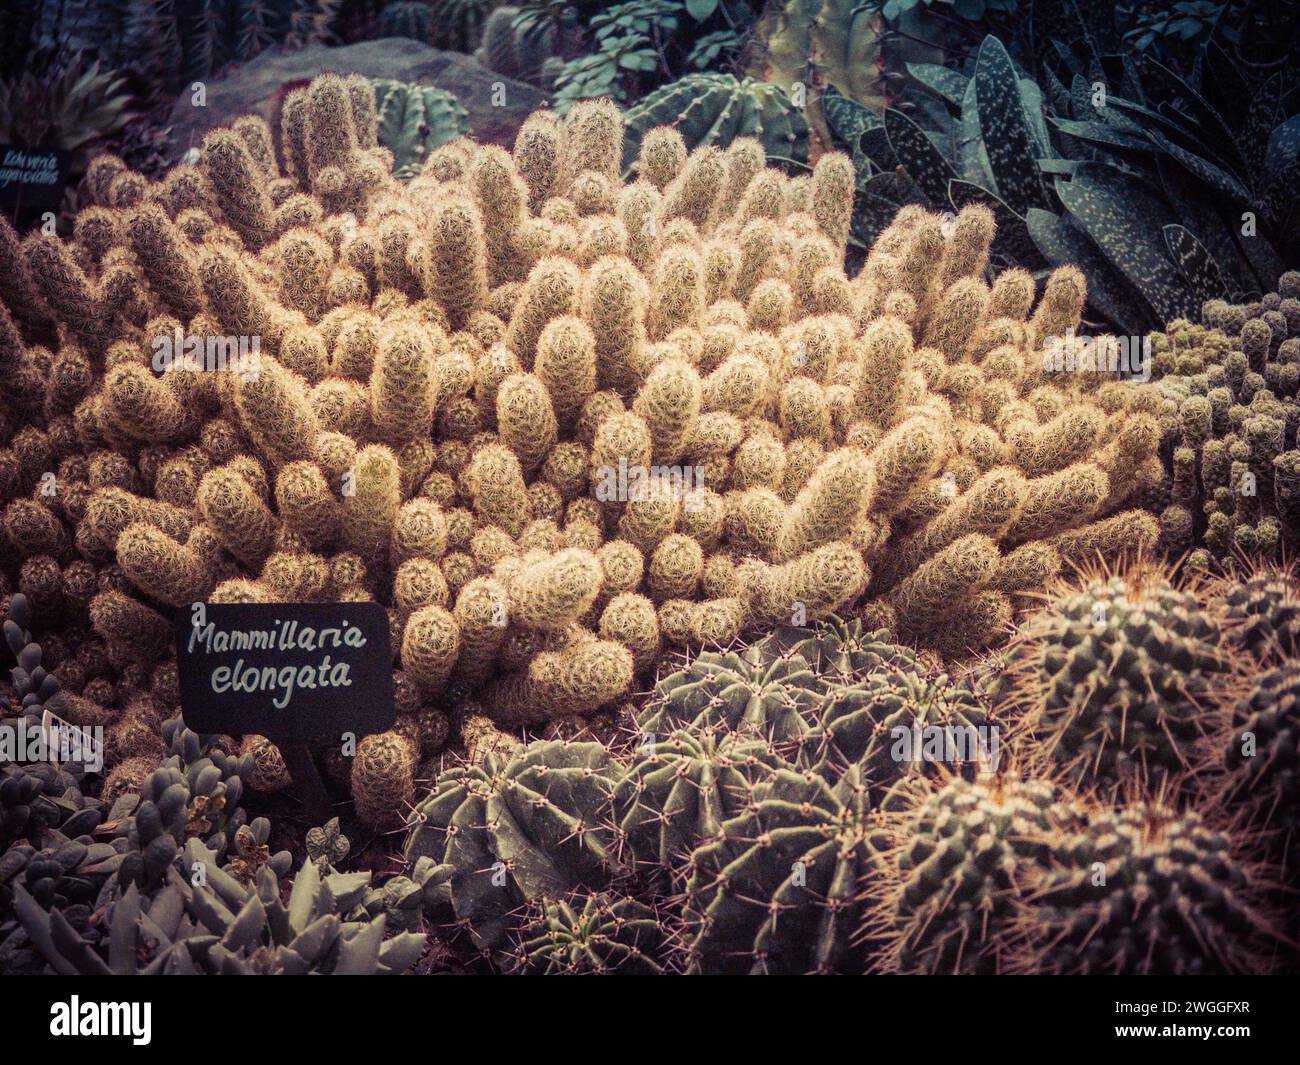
left=1013, top=804, right=1279, bottom=975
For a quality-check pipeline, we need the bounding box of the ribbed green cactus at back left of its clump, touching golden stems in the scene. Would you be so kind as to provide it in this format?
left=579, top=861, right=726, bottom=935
left=637, top=651, right=826, bottom=743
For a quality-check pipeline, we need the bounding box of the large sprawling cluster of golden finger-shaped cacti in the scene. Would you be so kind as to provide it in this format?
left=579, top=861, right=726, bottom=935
left=0, top=75, right=1160, bottom=827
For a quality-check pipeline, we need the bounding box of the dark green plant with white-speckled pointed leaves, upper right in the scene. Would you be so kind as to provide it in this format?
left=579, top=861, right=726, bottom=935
left=823, top=25, right=1300, bottom=333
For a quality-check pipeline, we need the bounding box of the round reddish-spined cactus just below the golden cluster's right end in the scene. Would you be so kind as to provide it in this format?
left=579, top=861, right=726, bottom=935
left=998, top=566, right=1230, bottom=787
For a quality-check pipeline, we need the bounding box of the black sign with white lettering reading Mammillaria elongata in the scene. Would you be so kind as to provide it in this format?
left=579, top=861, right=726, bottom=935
left=176, top=603, right=395, bottom=744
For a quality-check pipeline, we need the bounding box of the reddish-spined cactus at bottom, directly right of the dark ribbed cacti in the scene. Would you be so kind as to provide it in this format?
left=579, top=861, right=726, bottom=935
left=862, top=776, right=1075, bottom=974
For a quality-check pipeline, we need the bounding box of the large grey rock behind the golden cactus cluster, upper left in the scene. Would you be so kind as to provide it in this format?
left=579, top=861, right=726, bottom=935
left=168, top=38, right=549, bottom=159
